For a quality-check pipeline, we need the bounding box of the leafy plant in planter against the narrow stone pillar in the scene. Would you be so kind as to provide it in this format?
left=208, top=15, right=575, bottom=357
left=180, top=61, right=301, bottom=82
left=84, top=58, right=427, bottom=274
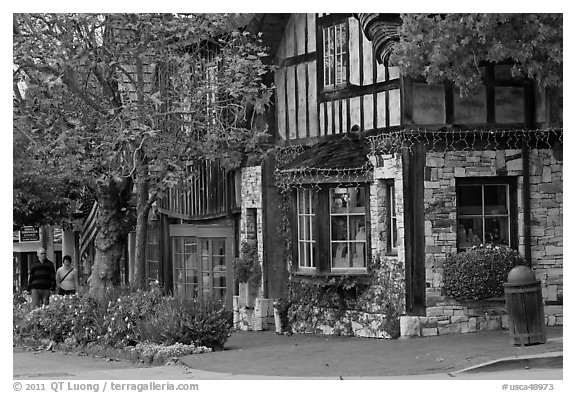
left=234, top=241, right=262, bottom=307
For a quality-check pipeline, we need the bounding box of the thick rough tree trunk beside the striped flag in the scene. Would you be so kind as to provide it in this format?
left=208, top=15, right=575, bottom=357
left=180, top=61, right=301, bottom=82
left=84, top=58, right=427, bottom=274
left=89, top=180, right=131, bottom=295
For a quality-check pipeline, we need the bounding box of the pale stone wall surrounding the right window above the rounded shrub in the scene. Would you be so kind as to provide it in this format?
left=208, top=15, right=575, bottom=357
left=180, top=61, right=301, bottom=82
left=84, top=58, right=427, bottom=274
left=424, top=149, right=563, bottom=325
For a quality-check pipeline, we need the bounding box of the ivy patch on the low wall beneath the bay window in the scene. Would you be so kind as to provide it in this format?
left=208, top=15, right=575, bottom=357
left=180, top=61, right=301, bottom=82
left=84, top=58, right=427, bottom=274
left=287, top=258, right=405, bottom=338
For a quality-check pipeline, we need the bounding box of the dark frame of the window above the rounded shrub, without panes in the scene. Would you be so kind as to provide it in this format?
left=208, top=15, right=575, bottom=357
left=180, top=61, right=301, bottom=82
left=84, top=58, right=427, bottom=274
left=455, top=176, right=518, bottom=252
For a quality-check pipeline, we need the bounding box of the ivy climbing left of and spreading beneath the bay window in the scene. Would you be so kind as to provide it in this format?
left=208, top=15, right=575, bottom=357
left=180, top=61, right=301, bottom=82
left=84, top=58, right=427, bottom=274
left=275, top=146, right=405, bottom=338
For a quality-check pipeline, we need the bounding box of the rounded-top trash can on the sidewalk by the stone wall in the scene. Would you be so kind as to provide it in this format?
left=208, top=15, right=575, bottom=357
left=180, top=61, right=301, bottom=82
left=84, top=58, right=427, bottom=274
left=504, top=265, right=546, bottom=346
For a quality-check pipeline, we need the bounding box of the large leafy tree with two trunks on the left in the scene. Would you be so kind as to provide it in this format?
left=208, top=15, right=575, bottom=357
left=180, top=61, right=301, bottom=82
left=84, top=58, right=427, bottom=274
left=14, top=14, right=271, bottom=291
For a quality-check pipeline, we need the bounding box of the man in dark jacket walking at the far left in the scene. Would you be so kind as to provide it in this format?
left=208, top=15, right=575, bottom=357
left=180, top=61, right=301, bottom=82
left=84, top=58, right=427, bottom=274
left=28, top=247, right=56, bottom=307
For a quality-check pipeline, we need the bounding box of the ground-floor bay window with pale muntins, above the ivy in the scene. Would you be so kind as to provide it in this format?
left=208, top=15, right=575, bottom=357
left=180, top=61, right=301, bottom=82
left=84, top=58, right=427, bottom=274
left=295, top=186, right=369, bottom=274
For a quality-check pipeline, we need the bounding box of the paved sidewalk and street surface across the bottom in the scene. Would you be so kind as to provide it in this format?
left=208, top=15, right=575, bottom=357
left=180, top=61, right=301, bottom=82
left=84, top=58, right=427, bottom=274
left=13, top=329, right=563, bottom=381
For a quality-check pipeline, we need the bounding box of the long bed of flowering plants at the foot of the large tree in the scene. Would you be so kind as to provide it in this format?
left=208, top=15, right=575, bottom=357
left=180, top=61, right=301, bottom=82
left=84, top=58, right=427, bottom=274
left=13, top=288, right=232, bottom=348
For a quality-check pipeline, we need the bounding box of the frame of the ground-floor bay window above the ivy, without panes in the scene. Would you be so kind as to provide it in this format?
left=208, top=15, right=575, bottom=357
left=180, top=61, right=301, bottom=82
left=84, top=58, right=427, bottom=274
left=292, top=182, right=372, bottom=276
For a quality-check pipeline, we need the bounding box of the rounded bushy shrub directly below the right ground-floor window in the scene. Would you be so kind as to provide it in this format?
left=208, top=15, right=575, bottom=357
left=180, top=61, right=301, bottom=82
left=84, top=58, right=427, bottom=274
left=444, top=245, right=526, bottom=300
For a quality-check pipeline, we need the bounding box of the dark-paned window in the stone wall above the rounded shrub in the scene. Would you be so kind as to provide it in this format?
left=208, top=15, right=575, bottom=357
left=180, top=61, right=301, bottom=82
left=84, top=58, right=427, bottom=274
left=456, top=179, right=516, bottom=250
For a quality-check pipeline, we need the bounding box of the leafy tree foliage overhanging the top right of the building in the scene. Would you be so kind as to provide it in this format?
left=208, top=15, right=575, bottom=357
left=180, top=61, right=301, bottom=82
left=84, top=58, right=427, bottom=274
left=391, top=14, right=563, bottom=95
